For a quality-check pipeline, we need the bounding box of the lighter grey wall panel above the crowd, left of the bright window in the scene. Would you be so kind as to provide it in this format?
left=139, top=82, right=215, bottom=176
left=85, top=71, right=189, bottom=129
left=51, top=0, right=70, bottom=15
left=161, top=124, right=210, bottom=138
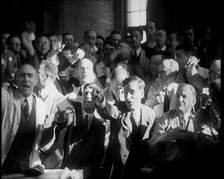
left=62, top=0, right=114, bottom=42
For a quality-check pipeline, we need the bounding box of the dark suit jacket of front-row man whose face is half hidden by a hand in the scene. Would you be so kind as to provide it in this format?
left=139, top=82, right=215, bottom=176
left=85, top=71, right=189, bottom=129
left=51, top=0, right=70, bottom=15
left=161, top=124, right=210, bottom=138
left=62, top=105, right=105, bottom=179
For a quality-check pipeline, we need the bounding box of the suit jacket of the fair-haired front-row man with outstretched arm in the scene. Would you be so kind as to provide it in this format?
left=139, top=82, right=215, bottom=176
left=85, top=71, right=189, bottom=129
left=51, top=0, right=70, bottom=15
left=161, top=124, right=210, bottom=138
left=100, top=102, right=155, bottom=178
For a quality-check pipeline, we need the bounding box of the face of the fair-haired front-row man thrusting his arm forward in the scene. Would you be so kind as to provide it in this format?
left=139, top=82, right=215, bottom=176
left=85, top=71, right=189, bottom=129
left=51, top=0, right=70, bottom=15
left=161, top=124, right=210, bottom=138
left=124, top=81, right=144, bottom=111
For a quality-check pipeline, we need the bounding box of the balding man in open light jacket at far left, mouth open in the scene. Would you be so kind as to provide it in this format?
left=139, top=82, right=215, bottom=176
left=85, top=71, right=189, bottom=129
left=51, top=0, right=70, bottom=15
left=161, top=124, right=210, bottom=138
left=1, top=64, right=46, bottom=174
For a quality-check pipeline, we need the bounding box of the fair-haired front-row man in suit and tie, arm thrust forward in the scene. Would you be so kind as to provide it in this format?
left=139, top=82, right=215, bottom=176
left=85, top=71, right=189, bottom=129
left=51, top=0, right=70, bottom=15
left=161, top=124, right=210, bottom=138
left=100, top=76, right=155, bottom=178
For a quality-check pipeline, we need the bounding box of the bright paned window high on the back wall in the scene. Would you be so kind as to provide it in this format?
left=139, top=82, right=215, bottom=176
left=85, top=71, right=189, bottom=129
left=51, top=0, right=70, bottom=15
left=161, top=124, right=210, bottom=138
left=127, top=0, right=148, bottom=27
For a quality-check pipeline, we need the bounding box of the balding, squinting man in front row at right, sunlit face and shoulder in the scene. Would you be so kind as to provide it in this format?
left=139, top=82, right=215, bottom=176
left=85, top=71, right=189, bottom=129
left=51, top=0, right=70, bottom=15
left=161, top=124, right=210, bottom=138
left=148, top=83, right=196, bottom=178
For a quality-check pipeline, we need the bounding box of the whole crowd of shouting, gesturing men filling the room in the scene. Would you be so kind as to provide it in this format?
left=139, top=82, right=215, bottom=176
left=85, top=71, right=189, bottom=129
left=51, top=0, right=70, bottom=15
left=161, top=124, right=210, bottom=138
left=1, top=21, right=223, bottom=179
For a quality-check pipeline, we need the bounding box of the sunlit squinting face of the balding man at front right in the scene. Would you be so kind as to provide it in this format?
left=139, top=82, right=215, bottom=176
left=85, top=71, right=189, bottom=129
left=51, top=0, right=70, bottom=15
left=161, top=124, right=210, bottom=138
left=176, top=86, right=196, bottom=114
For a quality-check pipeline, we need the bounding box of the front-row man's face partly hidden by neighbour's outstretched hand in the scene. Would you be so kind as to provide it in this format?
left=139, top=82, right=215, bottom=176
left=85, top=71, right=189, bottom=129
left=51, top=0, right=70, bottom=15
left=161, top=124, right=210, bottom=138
left=82, top=86, right=96, bottom=114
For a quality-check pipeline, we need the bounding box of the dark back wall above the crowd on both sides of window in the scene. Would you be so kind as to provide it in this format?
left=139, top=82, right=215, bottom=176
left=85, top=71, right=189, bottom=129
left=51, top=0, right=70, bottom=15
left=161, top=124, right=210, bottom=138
left=0, top=0, right=224, bottom=44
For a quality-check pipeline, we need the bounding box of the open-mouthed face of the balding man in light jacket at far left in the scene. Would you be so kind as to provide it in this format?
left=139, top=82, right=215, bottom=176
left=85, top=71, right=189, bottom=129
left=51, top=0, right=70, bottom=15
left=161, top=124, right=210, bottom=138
left=17, top=65, right=37, bottom=97
